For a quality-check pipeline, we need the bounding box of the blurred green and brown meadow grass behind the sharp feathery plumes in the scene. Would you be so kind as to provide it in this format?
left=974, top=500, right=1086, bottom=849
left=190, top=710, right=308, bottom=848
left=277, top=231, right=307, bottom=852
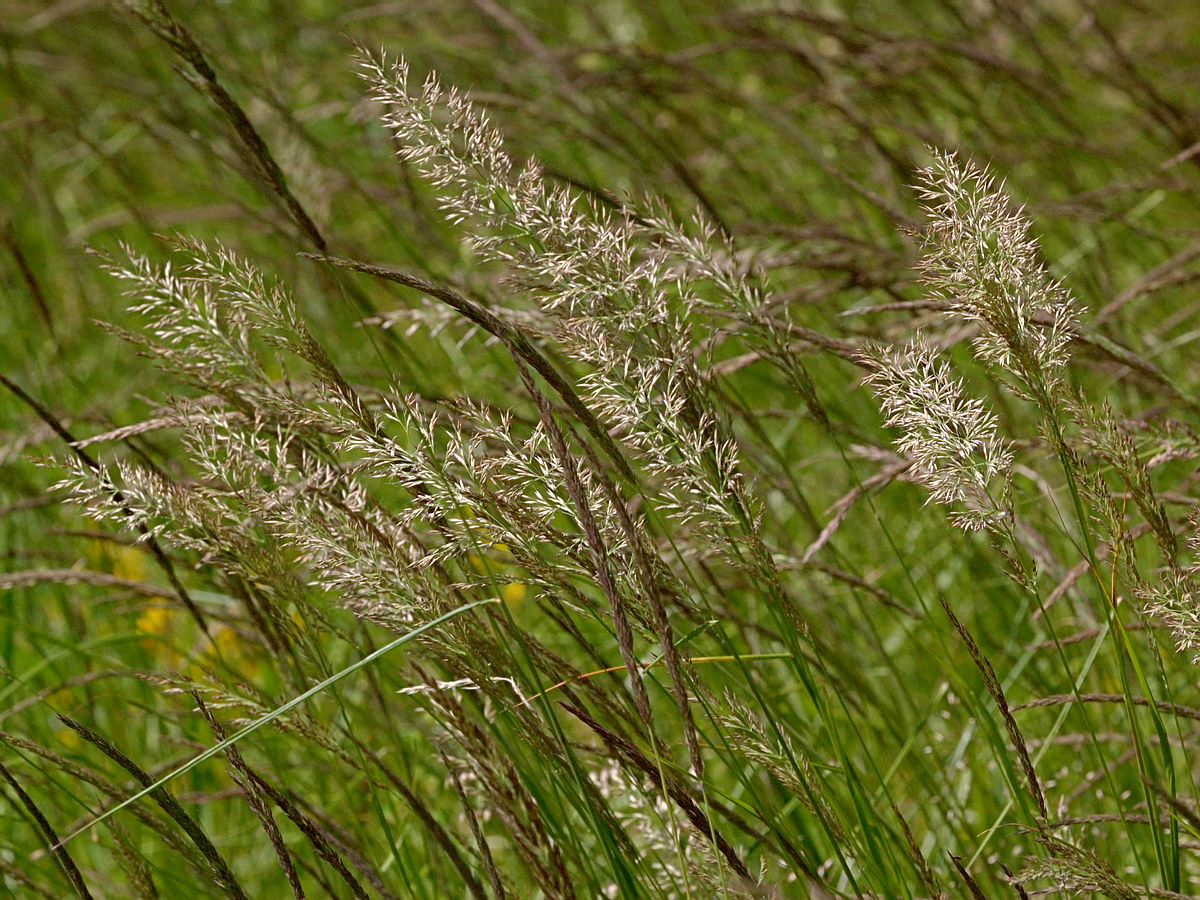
left=0, top=0, right=1200, bottom=899
